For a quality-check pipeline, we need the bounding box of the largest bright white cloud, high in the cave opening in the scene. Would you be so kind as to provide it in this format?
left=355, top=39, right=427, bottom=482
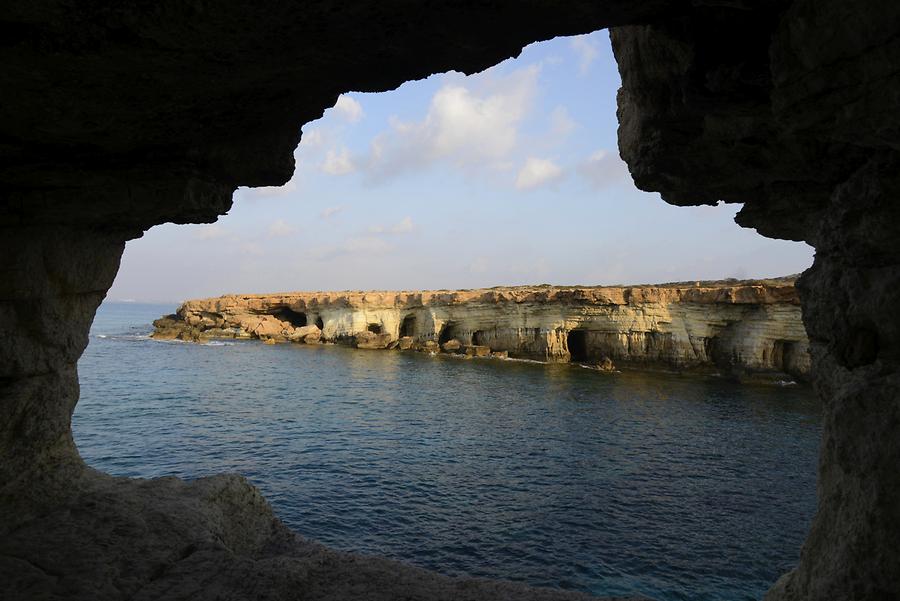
left=366, top=65, right=540, bottom=179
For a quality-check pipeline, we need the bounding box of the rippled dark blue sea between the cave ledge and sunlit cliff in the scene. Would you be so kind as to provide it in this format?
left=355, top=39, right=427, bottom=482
left=73, top=304, right=820, bottom=601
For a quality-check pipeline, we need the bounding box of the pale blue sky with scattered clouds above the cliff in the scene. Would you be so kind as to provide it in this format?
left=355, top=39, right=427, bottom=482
left=107, top=31, right=813, bottom=302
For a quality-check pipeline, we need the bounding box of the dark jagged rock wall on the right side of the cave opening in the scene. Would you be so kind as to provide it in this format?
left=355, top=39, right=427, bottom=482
left=612, top=0, right=900, bottom=601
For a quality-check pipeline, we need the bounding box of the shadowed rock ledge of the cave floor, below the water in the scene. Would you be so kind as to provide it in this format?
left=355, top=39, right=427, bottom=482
left=0, top=469, right=640, bottom=601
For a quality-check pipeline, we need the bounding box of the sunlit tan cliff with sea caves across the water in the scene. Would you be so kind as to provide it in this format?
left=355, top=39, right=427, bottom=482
left=155, top=282, right=809, bottom=377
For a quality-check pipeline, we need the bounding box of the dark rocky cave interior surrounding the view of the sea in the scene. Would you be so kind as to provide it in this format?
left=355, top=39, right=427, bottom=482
left=0, top=0, right=900, bottom=601
